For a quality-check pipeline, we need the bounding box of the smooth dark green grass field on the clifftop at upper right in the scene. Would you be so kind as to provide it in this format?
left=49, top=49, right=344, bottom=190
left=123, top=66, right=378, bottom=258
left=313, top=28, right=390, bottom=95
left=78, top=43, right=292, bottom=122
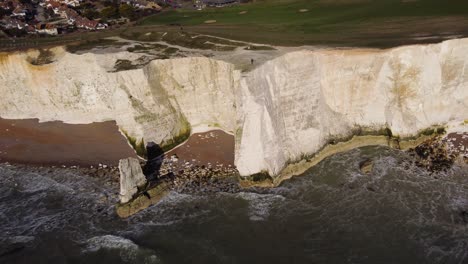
left=140, top=0, right=468, bottom=46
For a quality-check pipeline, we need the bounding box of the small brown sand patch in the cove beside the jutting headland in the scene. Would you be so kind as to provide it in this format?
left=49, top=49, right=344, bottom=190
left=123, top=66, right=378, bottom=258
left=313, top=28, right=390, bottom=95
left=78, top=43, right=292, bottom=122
left=165, top=130, right=234, bottom=167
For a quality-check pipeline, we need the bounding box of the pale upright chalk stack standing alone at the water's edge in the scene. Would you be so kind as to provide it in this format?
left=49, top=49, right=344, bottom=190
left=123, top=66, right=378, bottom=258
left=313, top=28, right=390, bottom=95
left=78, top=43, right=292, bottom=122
left=119, top=158, right=147, bottom=203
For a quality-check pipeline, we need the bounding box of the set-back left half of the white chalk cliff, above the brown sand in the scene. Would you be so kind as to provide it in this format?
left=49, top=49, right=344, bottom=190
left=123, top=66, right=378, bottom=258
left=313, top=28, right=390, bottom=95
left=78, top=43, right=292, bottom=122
left=0, top=49, right=239, bottom=148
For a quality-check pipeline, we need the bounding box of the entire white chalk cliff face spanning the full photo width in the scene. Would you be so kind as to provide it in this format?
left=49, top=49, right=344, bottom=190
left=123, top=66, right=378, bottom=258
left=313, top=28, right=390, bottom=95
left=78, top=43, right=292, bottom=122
left=0, top=39, right=468, bottom=175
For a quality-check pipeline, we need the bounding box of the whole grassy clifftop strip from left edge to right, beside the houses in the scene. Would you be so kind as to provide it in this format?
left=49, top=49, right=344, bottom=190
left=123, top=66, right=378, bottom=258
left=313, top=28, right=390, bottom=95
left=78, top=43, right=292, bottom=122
left=0, top=0, right=468, bottom=50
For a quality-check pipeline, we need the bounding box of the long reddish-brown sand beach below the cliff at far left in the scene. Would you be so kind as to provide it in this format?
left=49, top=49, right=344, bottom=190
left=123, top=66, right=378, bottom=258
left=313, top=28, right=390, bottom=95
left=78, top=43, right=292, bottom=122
left=0, top=118, right=136, bottom=166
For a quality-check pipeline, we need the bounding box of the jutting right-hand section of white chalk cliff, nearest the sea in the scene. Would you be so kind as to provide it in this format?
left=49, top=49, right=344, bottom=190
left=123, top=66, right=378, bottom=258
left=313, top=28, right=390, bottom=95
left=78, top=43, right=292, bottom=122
left=236, top=39, right=468, bottom=175
